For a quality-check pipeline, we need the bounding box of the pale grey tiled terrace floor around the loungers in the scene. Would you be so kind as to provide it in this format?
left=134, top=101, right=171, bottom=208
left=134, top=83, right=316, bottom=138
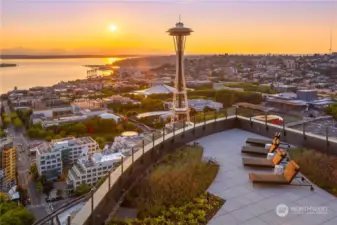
left=198, top=129, right=337, bottom=225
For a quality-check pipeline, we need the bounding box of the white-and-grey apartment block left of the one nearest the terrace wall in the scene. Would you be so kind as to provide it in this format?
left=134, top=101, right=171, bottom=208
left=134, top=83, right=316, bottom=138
left=35, top=137, right=99, bottom=179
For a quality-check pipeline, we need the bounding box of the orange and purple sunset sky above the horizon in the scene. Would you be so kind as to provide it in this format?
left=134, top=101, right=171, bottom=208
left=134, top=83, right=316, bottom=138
left=0, top=0, right=337, bottom=54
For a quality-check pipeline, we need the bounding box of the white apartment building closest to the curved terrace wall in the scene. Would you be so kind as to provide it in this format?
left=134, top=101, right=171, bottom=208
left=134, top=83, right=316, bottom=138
left=66, top=150, right=124, bottom=189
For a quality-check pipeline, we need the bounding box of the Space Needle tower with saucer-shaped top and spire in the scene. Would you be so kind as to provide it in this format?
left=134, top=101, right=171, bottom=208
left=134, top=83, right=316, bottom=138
left=167, top=17, right=193, bottom=124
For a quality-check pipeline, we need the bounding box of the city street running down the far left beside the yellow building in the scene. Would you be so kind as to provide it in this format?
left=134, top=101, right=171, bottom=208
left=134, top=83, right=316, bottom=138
left=3, top=101, right=44, bottom=205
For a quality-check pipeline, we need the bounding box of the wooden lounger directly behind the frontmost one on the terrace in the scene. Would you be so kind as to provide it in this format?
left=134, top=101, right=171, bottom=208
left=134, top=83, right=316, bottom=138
left=242, top=149, right=287, bottom=168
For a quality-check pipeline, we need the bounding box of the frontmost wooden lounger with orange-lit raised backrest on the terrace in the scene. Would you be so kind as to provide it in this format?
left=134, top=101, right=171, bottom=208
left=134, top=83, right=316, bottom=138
left=249, top=160, right=314, bottom=191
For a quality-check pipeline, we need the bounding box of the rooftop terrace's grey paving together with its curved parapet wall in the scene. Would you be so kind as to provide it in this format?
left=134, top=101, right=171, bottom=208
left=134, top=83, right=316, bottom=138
left=61, top=116, right=337, bottom=225
